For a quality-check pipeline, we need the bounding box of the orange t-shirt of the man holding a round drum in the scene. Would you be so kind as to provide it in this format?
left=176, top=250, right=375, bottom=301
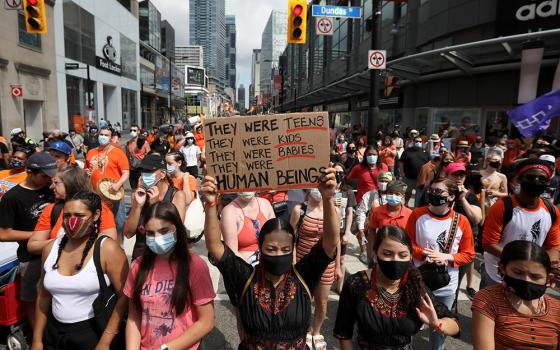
left=85, top=146, right=130, bottom=191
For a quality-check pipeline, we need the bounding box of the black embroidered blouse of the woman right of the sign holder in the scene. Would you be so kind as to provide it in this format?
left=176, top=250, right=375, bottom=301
left=334, top=268, right=457, bottom=349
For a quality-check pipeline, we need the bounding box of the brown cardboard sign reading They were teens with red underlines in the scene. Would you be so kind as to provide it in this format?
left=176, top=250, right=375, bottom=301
left=204, top=112, right=330, bottom=192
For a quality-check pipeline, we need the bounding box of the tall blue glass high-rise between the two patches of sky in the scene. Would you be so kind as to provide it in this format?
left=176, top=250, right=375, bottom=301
left=189, top=0, right=226, bottom=91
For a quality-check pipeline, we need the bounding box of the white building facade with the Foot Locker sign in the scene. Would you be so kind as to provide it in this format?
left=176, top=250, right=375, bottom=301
left=51, top=0, right=140, bottom=130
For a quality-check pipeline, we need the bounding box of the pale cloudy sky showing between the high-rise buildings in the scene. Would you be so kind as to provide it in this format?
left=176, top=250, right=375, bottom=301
left=152, top=0, right=285, bottom=105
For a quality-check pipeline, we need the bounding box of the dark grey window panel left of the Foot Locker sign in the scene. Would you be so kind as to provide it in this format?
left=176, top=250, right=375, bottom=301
left=63, top=1, right=95, bottom=65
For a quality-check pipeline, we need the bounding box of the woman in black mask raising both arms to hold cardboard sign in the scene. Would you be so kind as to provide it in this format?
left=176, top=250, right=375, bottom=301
left=202, top=169, right=340, bottom=350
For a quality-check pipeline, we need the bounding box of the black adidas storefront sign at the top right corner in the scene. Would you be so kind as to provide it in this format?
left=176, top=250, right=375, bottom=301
left=496, top=0, right=560, bottom=36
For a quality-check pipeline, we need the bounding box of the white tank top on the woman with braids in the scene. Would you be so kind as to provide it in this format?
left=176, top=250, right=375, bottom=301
left=43, top=237, right=111, bottom=323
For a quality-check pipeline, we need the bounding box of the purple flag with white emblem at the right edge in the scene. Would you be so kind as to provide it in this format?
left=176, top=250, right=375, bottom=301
left=507, top=89, right=560, bottom=137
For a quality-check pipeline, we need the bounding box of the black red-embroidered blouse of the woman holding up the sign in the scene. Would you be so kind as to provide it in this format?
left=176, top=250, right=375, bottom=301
left=216, top=242, right=334, bottom=350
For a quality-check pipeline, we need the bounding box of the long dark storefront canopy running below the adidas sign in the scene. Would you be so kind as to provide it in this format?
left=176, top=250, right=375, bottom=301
left=290, top=28, right=560, bottom=109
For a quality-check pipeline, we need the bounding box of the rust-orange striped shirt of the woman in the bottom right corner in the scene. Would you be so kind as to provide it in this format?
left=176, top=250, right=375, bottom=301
left=472, top=284, right=560, bottom=350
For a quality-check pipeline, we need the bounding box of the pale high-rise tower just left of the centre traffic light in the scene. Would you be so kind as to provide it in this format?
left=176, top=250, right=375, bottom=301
left=260, top=10, right=288, bottom=98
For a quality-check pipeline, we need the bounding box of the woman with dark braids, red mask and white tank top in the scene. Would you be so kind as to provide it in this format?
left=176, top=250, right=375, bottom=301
left=31, top=192, right=128, bottom=350
